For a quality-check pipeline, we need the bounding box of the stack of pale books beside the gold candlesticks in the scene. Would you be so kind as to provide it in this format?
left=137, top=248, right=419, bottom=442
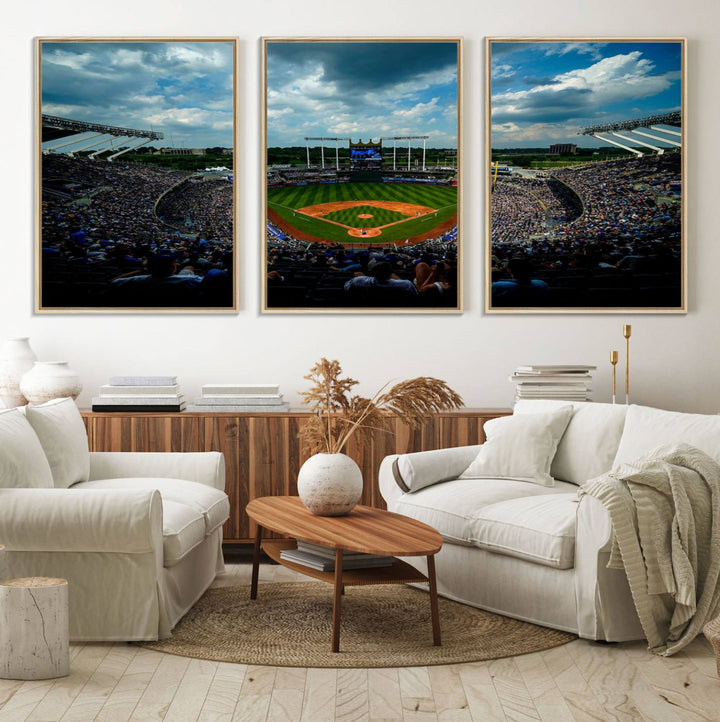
left=510, top=365, right=597, bottom=401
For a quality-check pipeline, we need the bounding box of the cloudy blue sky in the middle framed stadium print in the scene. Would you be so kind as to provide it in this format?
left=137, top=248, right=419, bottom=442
left=267, top=41, right=457, bottom=148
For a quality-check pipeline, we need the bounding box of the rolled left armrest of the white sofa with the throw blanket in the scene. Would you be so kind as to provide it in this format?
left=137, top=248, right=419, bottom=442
left=379, top=445, right=480, bottom=507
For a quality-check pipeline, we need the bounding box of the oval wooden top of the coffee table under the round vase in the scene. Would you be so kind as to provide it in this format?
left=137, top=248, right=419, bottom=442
left=245, top=496, right=442, bottom=557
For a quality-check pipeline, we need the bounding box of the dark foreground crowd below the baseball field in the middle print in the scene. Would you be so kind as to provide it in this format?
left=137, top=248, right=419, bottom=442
left=267, top=223, right=457, bottom=308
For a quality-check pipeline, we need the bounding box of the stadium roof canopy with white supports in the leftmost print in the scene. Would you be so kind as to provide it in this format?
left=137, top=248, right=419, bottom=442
left=41, top=114, right=164, bottom=160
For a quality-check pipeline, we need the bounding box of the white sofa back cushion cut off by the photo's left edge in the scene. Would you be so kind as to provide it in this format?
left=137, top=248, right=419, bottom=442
left=0, top=409, right=53, bottom=489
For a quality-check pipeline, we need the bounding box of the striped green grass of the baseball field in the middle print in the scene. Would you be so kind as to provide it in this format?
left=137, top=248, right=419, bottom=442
left=268, top=183, right=457, bottom=244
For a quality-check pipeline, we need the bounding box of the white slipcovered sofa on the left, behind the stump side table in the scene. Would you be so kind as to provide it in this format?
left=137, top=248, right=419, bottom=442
left=0, top=399, right=229, bottom=641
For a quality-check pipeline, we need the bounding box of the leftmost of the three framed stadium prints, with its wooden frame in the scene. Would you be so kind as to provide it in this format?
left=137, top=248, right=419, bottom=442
left=35, top=38, right=238, bottom=313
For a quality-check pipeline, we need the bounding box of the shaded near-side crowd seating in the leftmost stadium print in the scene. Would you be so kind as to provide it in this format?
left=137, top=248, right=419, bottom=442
left=42, top=155, right=233, bottom=307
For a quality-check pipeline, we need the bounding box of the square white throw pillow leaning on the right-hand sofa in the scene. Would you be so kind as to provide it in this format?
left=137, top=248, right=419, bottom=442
left=460, top=406, right=573, bottom=486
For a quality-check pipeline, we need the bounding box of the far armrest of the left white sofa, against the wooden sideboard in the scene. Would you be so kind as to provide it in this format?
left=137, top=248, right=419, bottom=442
left=89, top=451, right=225, bottom=491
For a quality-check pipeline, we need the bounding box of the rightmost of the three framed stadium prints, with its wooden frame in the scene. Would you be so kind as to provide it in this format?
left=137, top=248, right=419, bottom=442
left=485, top=38, right=687, bottom=313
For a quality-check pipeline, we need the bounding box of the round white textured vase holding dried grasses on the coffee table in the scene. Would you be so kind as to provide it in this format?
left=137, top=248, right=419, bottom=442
left=298, top=454, right=363, bottom=516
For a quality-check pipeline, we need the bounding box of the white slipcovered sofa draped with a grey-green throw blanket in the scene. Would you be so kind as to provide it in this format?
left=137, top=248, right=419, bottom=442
left=380, top=401, right=720, bottom=641
